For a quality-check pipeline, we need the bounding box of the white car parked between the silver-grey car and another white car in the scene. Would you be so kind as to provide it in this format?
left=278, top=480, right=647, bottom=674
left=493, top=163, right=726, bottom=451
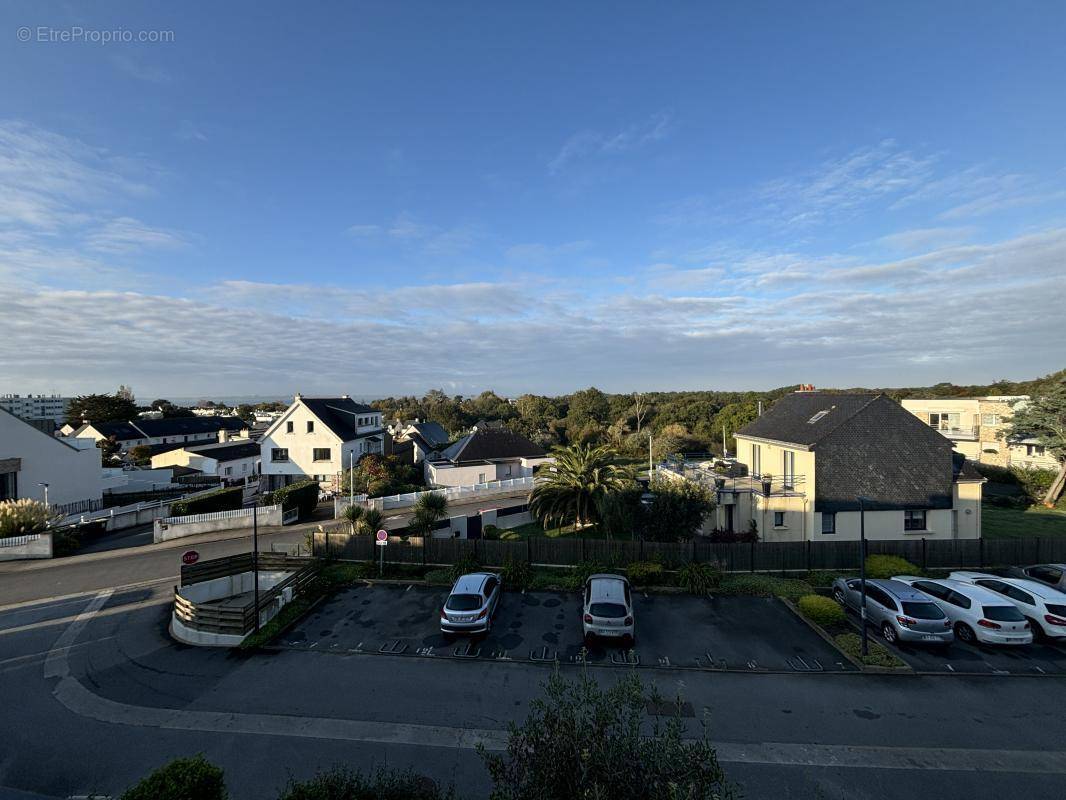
left=892, top=575, right=1033, bottom=644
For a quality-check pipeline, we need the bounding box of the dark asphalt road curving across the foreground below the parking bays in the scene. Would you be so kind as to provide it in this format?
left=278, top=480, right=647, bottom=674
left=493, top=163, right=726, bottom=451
left=6, top=571, right=1066, bottom=800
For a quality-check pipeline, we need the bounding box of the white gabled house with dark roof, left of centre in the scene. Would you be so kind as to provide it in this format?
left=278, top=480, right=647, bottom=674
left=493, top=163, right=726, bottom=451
left=259, top=395, right=392, bottom=491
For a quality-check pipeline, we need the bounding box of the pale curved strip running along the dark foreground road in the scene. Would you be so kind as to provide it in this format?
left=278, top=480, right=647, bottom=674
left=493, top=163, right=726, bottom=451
left=45, top=590, right=1066, bottom=774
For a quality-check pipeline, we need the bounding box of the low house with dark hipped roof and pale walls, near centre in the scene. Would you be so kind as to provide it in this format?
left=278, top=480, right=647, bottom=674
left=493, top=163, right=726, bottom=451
left=423, top=421, right=554, bottom=486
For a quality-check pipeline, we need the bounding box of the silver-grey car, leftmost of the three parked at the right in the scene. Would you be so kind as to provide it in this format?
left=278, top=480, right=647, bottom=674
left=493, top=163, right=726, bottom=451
left=833, top=578, right=955, bottom=644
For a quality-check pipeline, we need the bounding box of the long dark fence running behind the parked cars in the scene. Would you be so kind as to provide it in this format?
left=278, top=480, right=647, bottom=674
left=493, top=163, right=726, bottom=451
left=313, top=533, right=1066, bottom=573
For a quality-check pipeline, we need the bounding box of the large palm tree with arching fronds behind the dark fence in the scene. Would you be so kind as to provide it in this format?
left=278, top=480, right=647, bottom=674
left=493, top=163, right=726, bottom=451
left=530, top=445, right=633, bottom=528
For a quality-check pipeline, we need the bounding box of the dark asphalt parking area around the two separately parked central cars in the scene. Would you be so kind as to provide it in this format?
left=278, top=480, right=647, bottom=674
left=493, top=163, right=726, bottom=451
left=278, top=585, right=855, bottom=672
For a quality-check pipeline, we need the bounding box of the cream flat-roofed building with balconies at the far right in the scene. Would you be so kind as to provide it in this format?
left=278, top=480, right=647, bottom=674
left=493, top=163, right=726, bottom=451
left=903, top=395, right=1060, bottom=469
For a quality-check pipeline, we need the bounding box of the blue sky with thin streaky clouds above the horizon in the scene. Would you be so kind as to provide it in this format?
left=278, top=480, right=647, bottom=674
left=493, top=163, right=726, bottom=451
left=0, top=2, right=1066, bottom=397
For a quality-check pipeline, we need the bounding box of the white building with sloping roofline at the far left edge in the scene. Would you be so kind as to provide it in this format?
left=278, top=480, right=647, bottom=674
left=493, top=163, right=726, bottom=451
left=0, top=410, right=103, bottom=506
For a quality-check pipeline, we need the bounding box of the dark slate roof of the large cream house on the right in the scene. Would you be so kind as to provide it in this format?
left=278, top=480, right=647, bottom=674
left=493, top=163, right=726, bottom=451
left=737, top=393, right=965, bottom=512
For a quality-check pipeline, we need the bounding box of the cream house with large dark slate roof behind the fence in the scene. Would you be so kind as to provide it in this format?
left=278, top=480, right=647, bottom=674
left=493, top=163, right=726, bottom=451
left=677, top=391, right=984, bottom=542
